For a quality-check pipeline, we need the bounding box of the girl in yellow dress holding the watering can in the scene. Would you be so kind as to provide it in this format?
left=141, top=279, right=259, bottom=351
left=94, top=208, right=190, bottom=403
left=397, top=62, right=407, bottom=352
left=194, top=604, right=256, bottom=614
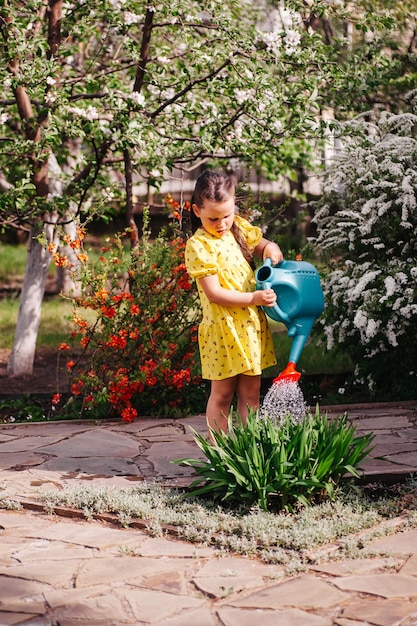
left=185, top=170, right=283, bottom=433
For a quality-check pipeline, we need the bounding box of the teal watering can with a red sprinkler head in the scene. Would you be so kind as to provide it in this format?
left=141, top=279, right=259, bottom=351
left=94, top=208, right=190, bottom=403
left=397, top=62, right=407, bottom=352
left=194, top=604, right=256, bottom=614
left=255, top=258, right=324, bottom=382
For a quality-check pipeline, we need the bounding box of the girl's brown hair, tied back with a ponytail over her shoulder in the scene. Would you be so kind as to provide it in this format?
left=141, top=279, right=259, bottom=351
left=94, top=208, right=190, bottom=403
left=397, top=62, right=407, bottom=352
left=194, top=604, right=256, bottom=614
left=191, top=170, right=253, bottom=265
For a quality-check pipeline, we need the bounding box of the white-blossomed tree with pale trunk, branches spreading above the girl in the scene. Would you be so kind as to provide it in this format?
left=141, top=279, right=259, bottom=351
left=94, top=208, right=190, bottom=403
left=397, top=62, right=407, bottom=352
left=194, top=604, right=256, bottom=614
left=0, top=0, right=414, bottom=375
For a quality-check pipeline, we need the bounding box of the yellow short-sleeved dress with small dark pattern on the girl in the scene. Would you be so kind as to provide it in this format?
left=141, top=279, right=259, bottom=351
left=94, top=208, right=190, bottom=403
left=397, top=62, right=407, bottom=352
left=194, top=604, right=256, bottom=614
left=185, top=215, right=276, bottom=380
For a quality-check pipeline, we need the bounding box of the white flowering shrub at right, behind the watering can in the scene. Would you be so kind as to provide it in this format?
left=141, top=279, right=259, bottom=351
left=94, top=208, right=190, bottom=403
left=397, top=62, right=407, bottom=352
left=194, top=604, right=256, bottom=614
left=312, top=94, right=417, bottom=399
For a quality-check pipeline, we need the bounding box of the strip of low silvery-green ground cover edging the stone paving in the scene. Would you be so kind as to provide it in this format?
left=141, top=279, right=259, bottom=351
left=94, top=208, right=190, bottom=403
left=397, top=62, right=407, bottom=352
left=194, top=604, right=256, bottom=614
left=0, top=479, right=417, bottom=575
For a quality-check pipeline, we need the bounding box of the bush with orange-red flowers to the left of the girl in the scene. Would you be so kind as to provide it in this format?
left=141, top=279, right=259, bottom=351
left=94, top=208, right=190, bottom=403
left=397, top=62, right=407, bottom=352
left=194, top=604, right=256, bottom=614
left=55, top=208, right=202, bottom=422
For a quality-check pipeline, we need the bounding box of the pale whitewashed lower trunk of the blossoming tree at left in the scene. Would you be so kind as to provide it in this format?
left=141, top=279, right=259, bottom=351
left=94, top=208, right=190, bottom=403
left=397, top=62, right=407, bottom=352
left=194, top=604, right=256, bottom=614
left=7, top=227, right=51, bottom=377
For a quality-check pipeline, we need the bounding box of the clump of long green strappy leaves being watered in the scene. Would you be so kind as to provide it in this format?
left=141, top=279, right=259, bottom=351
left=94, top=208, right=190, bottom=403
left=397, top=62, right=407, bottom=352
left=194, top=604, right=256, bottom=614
left=175, top=408, right=373, bottom=511
